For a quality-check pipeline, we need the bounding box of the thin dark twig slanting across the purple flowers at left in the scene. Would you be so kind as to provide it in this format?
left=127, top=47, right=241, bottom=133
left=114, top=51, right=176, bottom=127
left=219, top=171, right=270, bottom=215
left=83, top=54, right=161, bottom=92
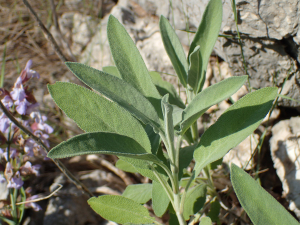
left=0, top=100, right=94, bottom=197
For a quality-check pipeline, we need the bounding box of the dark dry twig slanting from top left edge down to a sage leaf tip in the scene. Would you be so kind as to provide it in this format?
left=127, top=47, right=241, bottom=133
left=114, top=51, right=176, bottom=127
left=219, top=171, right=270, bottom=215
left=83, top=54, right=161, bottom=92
left=23, top=0, right=68, bottom=62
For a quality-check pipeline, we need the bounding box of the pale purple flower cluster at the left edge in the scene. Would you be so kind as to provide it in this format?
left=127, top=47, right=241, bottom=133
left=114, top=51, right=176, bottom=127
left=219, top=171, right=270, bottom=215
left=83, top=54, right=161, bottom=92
left=0, top=60, right=53, bottom=214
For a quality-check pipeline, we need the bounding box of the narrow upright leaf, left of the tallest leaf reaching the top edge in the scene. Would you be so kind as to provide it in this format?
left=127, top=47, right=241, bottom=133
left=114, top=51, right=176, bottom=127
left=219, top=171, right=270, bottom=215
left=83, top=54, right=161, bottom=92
left=159, top=16, right=188, bottom=87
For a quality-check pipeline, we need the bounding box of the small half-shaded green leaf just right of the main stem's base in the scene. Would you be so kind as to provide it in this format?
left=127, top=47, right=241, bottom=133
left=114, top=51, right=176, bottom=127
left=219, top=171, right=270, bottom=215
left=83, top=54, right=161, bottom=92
left=183, top=184, right=206, bottom=220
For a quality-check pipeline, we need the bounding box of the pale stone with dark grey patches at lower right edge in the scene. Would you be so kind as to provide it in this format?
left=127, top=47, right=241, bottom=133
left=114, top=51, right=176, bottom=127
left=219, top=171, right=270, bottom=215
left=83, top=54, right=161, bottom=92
left=270, top=117, right=300, bottom=218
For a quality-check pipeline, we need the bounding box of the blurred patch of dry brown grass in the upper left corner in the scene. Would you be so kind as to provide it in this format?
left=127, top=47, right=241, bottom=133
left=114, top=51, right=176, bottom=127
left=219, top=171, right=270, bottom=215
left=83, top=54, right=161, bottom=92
left=0, top=0, right=114, bottom=89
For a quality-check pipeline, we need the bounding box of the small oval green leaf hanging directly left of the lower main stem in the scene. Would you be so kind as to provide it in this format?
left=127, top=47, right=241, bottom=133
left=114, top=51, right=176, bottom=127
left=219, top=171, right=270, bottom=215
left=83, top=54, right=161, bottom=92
left=152, top=181, right=170, bottom=217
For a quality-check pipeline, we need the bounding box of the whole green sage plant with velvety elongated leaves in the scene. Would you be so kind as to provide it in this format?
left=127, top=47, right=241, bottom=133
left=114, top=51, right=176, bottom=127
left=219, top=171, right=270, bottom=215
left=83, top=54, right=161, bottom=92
left=48, top=0, right=298, bottom=225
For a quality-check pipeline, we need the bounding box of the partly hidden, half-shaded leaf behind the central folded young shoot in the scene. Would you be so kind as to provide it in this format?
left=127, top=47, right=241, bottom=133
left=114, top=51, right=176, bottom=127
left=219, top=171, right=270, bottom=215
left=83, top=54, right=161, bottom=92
left=150, top=71, right=185, bottom=109
